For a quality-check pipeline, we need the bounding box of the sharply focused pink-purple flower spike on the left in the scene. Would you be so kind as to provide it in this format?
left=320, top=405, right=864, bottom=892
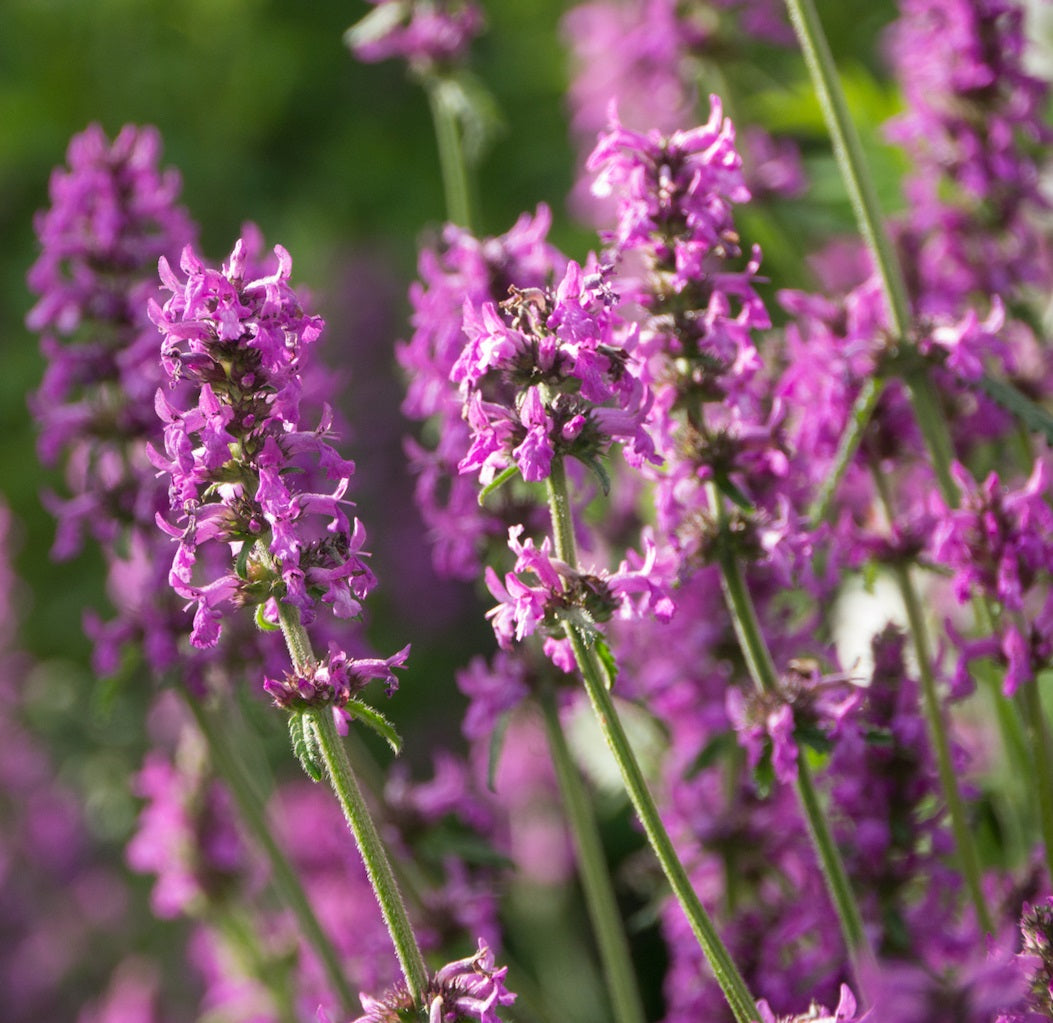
left=151, top=240, right=373, bottom=647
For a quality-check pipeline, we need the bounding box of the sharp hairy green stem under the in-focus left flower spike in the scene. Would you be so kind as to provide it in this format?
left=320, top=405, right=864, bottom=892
left=278, top=601, right=428, bottom=1004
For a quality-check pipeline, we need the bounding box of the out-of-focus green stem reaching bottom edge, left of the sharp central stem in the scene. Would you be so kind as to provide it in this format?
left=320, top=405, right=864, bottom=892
left=540, top=690, right=647, bottom=1023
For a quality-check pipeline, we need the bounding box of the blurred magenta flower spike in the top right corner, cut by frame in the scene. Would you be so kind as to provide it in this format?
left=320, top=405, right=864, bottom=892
left=888, top=0, right=1053, bottom=313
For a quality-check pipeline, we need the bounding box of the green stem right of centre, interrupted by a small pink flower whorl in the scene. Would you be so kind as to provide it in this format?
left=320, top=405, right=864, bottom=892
left=709, top=485, right=874, bottom=982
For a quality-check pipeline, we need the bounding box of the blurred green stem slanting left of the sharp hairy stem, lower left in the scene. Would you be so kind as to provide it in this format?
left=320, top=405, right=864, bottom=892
left=184, top=693, right=358, bottom=1015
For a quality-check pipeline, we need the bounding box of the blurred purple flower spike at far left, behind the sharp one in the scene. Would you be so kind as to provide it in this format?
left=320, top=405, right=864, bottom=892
left=26, top=124, right=196, bottom=558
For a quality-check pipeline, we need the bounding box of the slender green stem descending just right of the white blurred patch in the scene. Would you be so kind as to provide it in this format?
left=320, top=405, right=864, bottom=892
left=895, top=564, right=994, bottom=934
